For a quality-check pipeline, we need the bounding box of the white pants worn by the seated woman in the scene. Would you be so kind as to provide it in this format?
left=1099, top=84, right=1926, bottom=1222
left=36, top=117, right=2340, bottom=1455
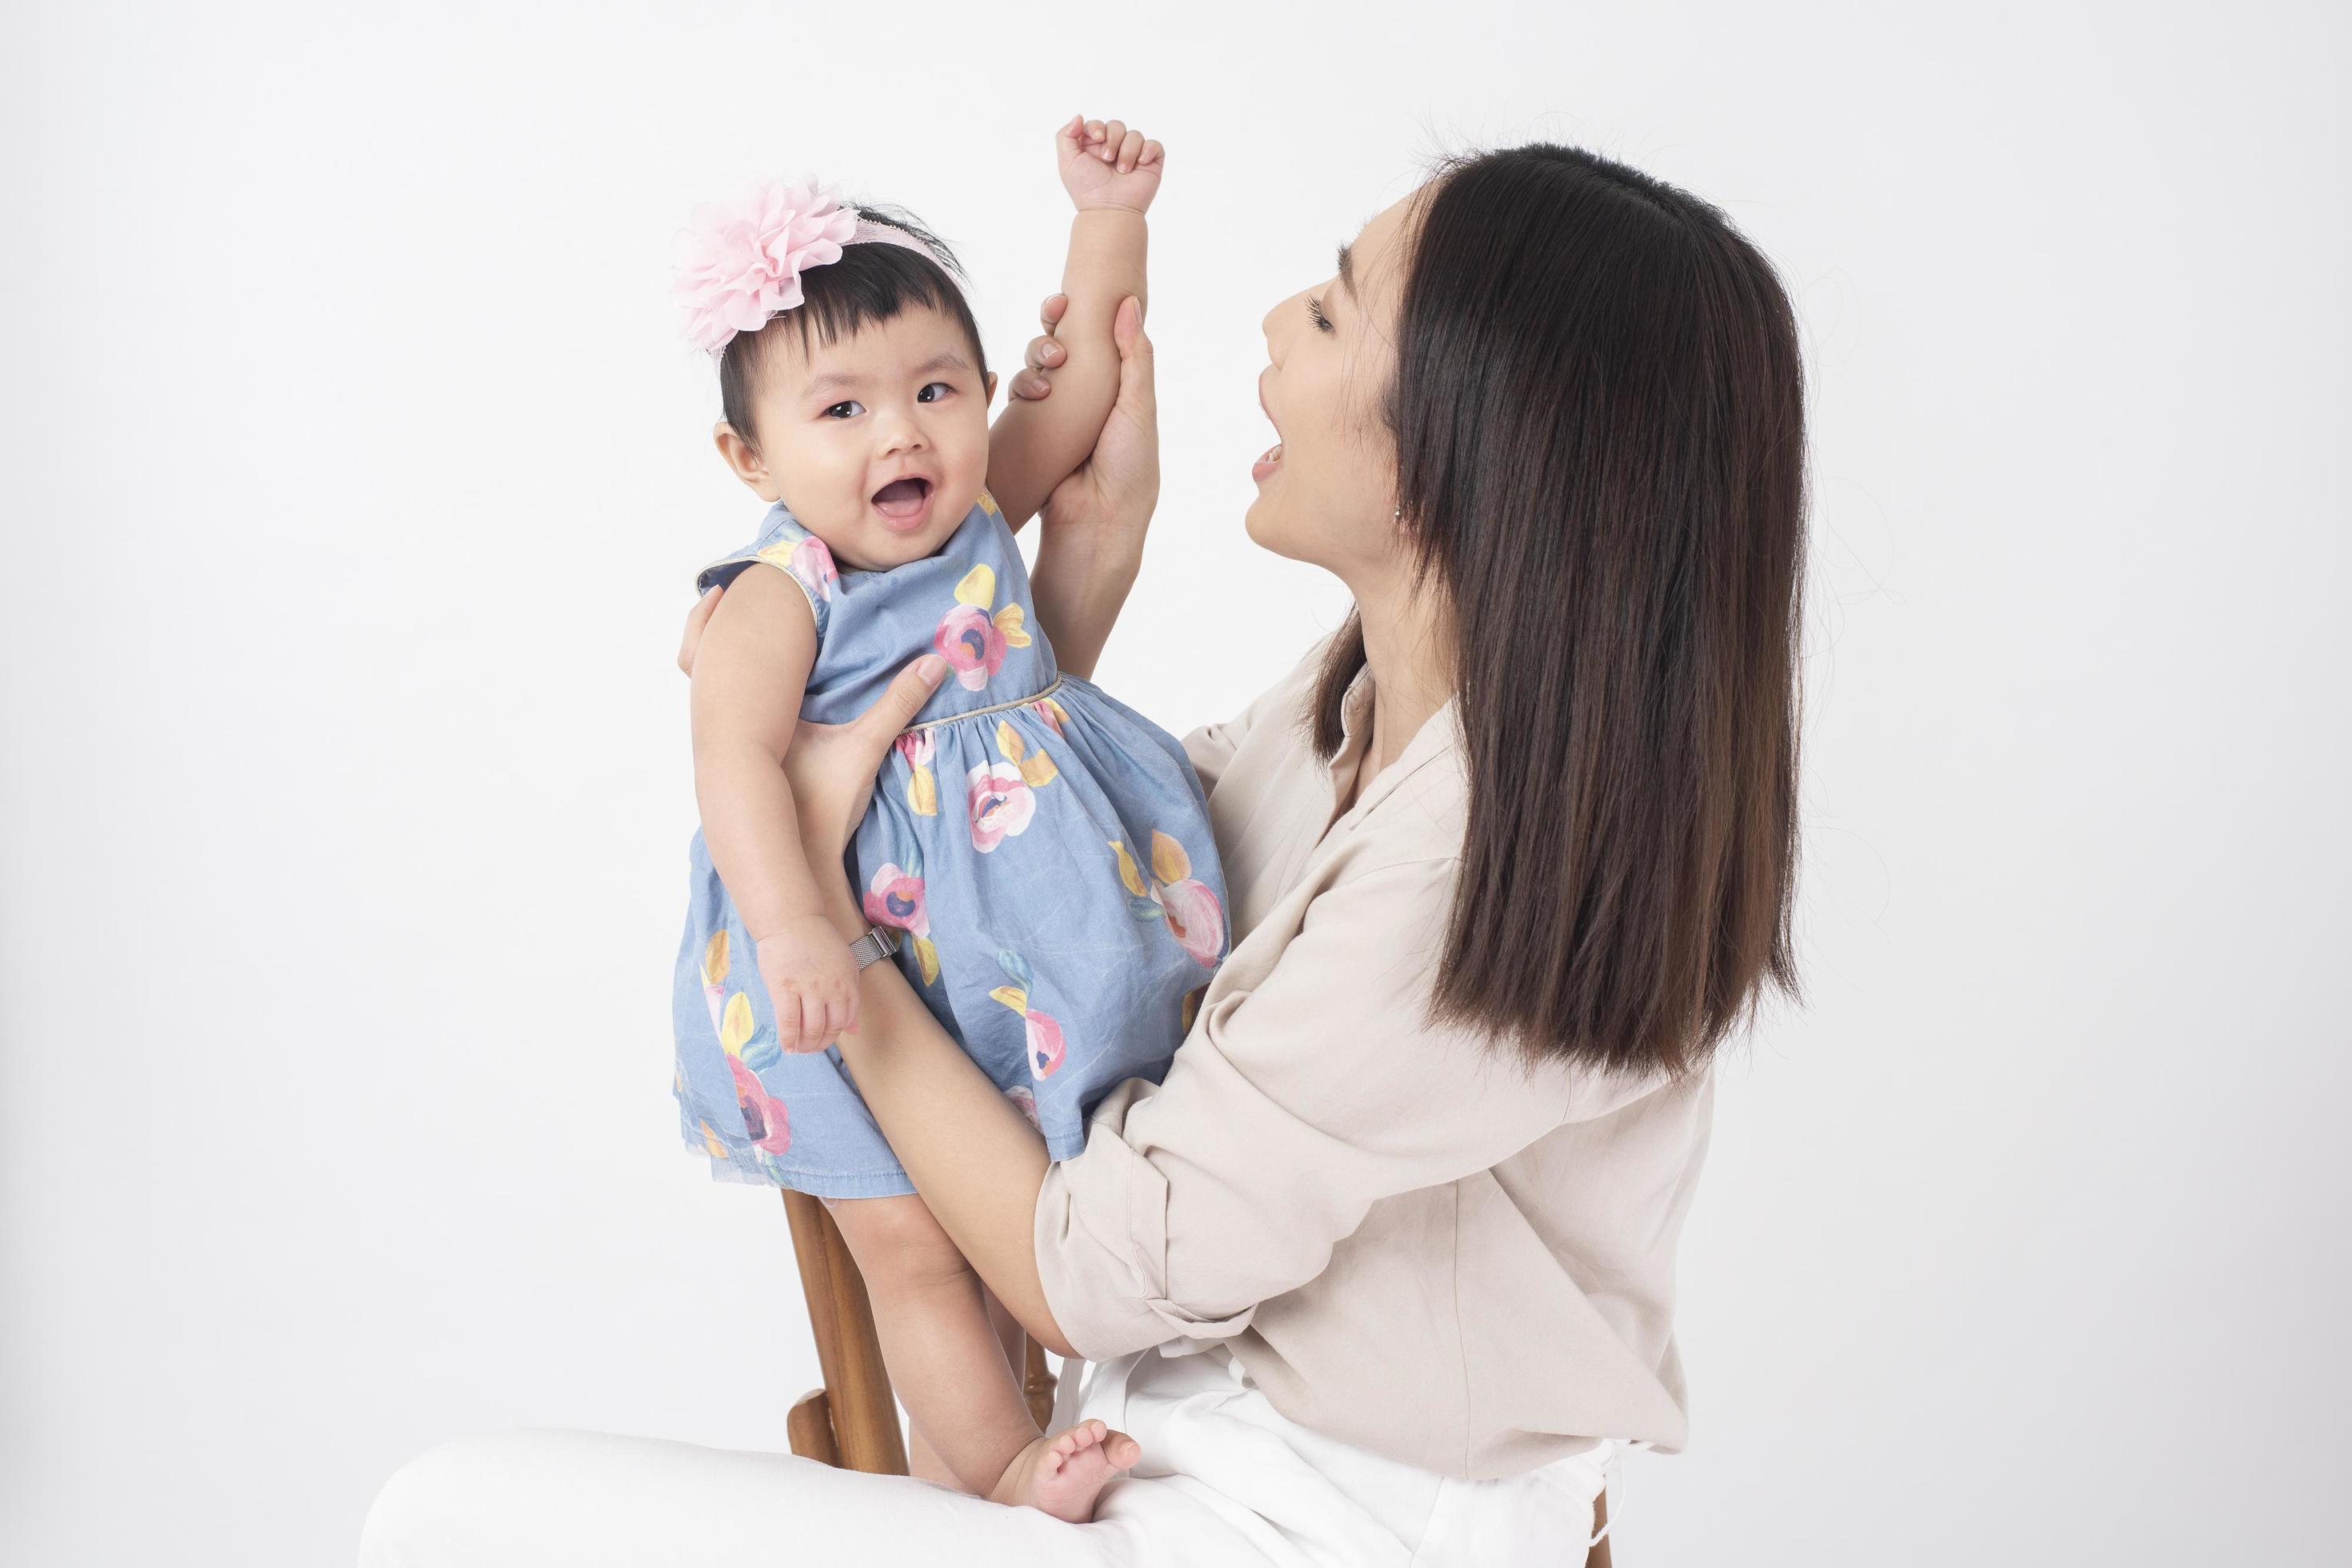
left=360, top=1350, right=1616, bottom=1568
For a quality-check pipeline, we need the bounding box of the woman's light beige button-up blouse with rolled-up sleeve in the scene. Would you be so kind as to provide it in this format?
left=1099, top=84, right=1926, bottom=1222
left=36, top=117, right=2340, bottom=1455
left=1035, top=642, right=1712, bottom=1478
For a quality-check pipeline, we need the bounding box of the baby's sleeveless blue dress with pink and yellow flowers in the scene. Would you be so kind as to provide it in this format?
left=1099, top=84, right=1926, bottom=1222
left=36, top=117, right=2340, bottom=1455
left=670, top=491, right=1226, bottom=1197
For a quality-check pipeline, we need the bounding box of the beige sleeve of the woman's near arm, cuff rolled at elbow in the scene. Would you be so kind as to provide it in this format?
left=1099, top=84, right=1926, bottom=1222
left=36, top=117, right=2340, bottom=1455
left=1035, top=856, right=1581, bottom=1361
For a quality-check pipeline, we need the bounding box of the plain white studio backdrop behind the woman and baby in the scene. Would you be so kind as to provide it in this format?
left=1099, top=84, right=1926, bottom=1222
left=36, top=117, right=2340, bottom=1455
left=0, top=0, right=2352, bottom=1568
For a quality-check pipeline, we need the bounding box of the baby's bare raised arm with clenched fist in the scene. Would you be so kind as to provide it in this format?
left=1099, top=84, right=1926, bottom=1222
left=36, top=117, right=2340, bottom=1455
left=988, top=115, right=1164, bottom=529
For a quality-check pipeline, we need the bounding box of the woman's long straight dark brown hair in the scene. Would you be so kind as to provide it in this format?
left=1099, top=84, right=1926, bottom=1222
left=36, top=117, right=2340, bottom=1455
left=1310, top=143, right=1806, bottom=1072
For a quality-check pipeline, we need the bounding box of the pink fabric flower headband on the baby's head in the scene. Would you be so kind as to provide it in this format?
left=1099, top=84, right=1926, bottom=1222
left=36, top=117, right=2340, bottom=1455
left=670, top=174, right=938, bottom=355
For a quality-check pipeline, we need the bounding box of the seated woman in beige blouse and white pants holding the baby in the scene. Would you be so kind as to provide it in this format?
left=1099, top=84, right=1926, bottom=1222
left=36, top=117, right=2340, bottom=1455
left=365, top=143, right=1804, bottom=1566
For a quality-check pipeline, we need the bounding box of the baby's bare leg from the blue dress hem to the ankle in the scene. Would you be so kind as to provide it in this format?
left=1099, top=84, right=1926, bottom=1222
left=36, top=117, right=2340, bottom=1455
left=826, top=1197, right=1038, bottom=1498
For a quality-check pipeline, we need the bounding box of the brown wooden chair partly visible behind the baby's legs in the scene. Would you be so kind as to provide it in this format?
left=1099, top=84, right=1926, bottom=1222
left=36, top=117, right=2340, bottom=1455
left=778, top=1187, right=1611, bottom=1568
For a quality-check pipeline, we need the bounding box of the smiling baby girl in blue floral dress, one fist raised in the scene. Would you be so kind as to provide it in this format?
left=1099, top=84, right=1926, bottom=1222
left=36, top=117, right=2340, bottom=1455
left=673, top=120, right=1226, bottom=1521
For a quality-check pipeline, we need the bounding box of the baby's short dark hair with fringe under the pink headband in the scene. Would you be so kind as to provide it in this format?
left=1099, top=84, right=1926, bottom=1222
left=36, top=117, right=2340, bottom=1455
left=720, top=202, right=988, bottom=451
